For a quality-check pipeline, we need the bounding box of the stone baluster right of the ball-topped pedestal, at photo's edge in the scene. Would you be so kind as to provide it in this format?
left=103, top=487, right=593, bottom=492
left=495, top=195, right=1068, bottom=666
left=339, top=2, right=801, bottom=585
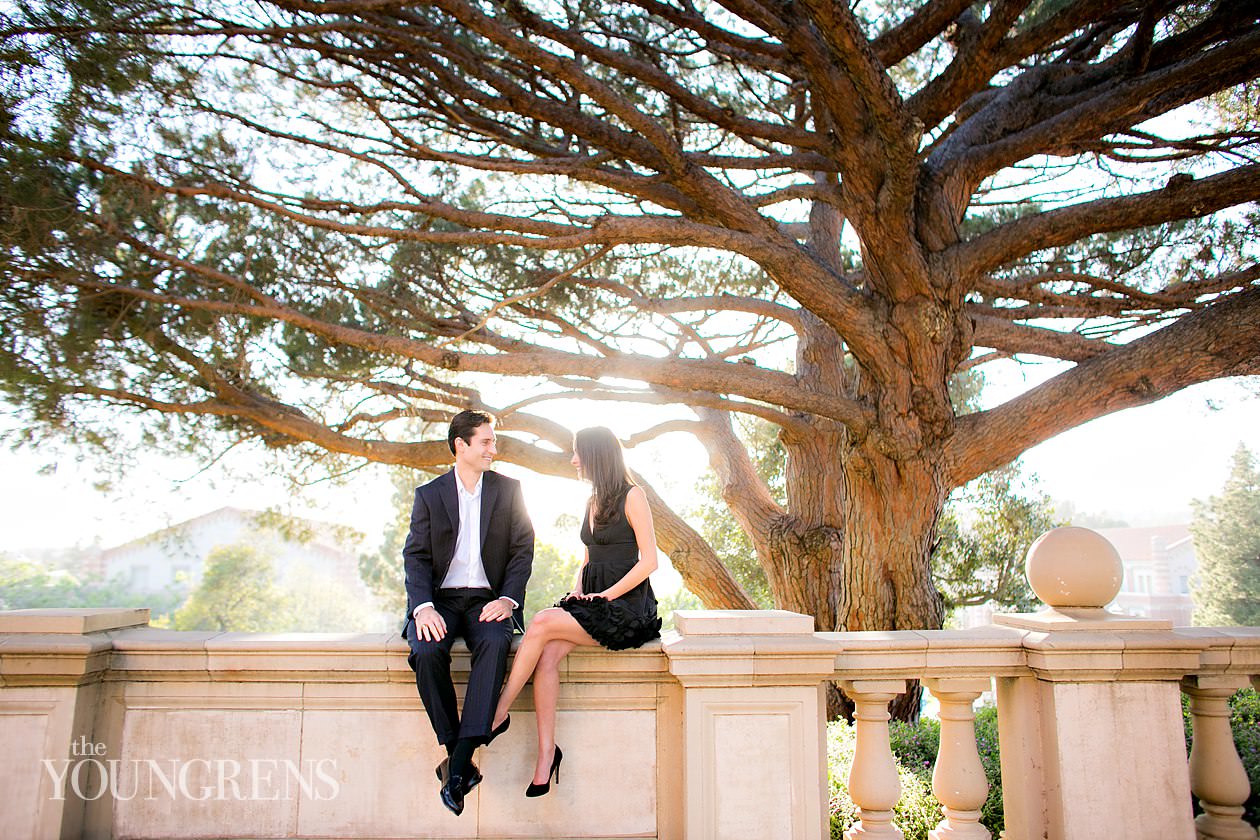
left=1182, top=675, right=1256, bottom=840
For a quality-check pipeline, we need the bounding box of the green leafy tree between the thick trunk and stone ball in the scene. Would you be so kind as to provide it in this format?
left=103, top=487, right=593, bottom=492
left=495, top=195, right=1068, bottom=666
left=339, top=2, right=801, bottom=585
left=932, top=461, right=1061, bottom=611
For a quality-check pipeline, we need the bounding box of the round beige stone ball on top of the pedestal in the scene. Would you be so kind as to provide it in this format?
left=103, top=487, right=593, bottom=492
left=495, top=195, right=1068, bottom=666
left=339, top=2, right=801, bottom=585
left=1024, top=526, right=1124, bottom=610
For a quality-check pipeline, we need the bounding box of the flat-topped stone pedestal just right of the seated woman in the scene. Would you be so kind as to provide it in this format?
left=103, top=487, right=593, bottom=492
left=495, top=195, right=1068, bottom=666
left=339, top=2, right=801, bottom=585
left=663, top=611, right=835, bottom=840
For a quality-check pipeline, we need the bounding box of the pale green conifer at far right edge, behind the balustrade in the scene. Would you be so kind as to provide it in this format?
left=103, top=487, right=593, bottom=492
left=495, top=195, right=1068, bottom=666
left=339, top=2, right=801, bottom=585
left=1191, top=443, right=1260, bottom=626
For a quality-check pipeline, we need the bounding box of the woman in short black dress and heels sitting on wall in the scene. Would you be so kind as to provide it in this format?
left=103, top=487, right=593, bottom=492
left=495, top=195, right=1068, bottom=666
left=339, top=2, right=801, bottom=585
left=493, top=427, right=660, bottom=796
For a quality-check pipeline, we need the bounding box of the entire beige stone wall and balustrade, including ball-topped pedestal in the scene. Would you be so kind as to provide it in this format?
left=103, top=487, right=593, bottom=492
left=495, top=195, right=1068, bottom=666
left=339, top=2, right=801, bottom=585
left=0, top=529, right=1260, bottom=840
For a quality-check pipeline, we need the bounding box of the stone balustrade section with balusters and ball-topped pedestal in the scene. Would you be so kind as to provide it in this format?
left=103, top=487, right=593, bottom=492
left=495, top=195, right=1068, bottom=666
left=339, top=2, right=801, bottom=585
left=815, top=528, right=1260, bottom=840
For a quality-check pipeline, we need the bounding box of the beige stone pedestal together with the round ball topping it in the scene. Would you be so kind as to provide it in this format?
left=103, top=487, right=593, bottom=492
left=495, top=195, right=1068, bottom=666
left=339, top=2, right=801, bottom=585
left=993, top=528, right=1205, bottom=840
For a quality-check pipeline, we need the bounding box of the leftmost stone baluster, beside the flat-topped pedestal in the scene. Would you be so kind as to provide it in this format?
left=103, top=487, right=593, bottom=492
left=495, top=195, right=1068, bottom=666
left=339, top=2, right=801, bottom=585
left=840, top=680, right=906, bottom=840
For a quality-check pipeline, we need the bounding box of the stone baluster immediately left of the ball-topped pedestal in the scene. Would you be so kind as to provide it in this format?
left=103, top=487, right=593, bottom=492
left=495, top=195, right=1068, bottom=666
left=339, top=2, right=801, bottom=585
left=924, top=679, right=990, bottom=840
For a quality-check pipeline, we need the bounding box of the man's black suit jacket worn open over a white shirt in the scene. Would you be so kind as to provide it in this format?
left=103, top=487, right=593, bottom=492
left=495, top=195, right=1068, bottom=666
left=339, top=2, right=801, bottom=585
left=402, top=470, right=534, bottom=635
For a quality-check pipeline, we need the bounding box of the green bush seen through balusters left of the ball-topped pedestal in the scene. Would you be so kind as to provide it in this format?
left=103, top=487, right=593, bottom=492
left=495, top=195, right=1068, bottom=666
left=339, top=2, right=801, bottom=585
left=827, top=707, right=1004, bottom=840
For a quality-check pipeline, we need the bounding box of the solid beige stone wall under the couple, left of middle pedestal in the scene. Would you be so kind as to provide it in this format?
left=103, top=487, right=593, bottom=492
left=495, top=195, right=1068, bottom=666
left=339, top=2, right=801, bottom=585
left=0, top=615, right=680, bottom=837
